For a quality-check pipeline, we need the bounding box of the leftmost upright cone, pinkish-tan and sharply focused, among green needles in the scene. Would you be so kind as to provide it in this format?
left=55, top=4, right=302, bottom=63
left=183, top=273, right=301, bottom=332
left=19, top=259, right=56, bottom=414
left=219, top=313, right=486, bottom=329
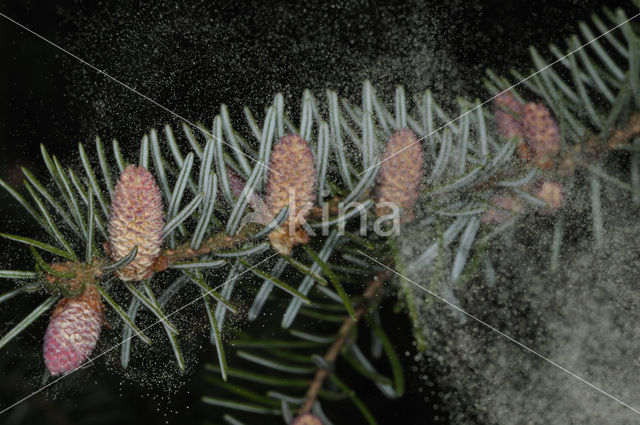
left=109, top=165, right=164, bottom=280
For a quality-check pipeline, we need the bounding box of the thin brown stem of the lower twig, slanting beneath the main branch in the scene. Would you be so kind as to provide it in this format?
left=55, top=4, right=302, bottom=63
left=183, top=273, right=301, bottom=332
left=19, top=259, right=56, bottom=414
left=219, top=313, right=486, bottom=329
left=299, top=270, right=392, bottom=415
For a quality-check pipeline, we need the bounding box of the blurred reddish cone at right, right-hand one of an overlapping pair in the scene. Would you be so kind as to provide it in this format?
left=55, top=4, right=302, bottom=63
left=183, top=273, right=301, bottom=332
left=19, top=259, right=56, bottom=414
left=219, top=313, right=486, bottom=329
left=522, top=103, right=560, bottom=169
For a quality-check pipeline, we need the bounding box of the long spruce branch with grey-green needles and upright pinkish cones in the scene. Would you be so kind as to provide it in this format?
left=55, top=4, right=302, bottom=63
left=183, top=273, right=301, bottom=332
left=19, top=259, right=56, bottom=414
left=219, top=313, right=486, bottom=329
left=0, top=5, right=640, bottom=423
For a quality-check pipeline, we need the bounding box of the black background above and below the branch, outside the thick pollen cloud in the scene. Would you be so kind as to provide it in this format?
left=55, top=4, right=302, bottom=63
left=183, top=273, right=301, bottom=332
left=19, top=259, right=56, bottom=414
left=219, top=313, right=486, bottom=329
left=0, top=0, right=633, bottom=424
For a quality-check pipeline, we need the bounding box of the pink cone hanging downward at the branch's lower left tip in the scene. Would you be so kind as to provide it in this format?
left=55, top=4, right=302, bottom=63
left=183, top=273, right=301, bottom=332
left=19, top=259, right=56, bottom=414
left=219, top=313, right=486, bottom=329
left=43, top=286, right=104, bottom=375
